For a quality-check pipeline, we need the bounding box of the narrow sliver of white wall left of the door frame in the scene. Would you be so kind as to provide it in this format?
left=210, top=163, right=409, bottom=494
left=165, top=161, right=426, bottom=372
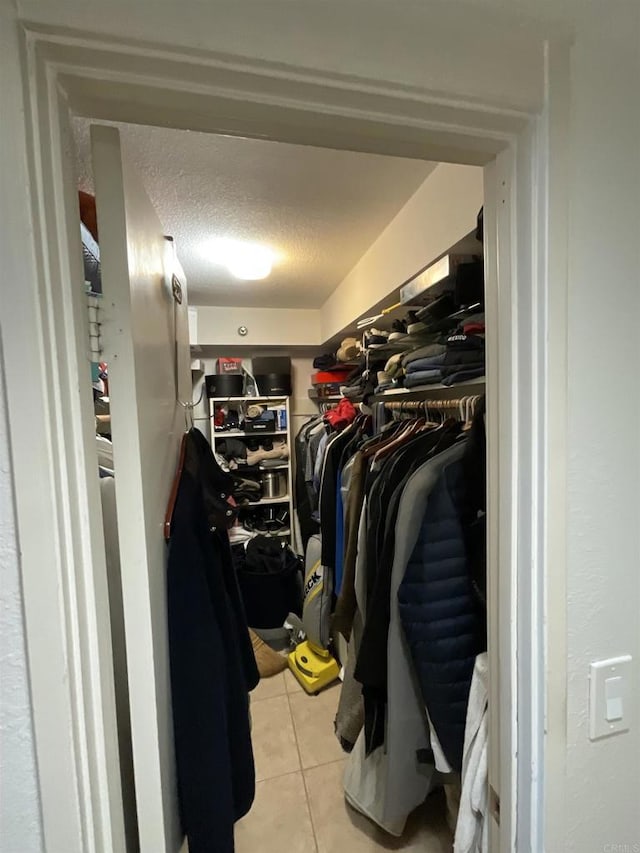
left=0, top=340, right=42, bottom=853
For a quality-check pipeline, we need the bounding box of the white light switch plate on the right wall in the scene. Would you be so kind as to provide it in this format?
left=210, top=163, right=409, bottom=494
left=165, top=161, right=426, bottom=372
left=589, top=655, right=635, bottom=740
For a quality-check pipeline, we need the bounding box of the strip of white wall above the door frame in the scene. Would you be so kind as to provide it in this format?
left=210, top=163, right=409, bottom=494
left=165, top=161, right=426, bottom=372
left=17, top=0, right=544, bottom=110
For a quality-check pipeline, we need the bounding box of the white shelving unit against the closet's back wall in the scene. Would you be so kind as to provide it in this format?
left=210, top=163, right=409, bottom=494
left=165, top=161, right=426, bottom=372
left=209, top=397, right=293, bottom=542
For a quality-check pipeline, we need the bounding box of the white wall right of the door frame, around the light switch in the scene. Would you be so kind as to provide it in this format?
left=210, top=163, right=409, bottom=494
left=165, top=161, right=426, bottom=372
left=560, top=23, right=640, bottom=853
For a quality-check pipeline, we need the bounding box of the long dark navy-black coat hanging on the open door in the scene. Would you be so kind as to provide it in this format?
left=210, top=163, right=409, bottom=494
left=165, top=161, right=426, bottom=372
left=167, top=430, right=259, bottom=853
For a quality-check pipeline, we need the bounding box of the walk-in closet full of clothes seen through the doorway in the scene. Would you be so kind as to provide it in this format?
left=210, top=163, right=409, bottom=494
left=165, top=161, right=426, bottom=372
left=73, top=119, right=492, bottom=853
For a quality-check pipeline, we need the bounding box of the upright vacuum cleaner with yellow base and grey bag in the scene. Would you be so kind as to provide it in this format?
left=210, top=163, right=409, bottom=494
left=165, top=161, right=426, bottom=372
left=289, top=536, right=340, bottom=693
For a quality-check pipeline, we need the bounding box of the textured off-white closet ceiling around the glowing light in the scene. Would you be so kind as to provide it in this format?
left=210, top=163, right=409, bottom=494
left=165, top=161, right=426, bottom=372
left=74, top=119, right=435, bottom=308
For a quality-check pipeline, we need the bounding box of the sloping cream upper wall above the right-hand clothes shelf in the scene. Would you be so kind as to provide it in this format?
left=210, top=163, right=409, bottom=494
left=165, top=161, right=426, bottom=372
left=322, top=163, right=483, bottom=340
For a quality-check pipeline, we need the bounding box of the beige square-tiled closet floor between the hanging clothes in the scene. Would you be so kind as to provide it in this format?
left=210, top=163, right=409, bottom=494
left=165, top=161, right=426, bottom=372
left=236, top=670, right=452, bottom=853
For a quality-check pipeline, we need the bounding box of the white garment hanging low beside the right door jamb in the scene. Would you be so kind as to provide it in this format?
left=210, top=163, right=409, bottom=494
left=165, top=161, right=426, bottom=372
left=453, top=652, right=489, bottom=853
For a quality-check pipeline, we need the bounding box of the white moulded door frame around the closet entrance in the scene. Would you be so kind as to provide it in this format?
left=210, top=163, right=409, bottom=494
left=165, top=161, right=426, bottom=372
left=4, top=20, right=564, bottom=853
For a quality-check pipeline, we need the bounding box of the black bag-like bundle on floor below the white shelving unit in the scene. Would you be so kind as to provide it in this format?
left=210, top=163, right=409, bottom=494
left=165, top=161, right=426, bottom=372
left=233, top=536, right=304, bottom=629
